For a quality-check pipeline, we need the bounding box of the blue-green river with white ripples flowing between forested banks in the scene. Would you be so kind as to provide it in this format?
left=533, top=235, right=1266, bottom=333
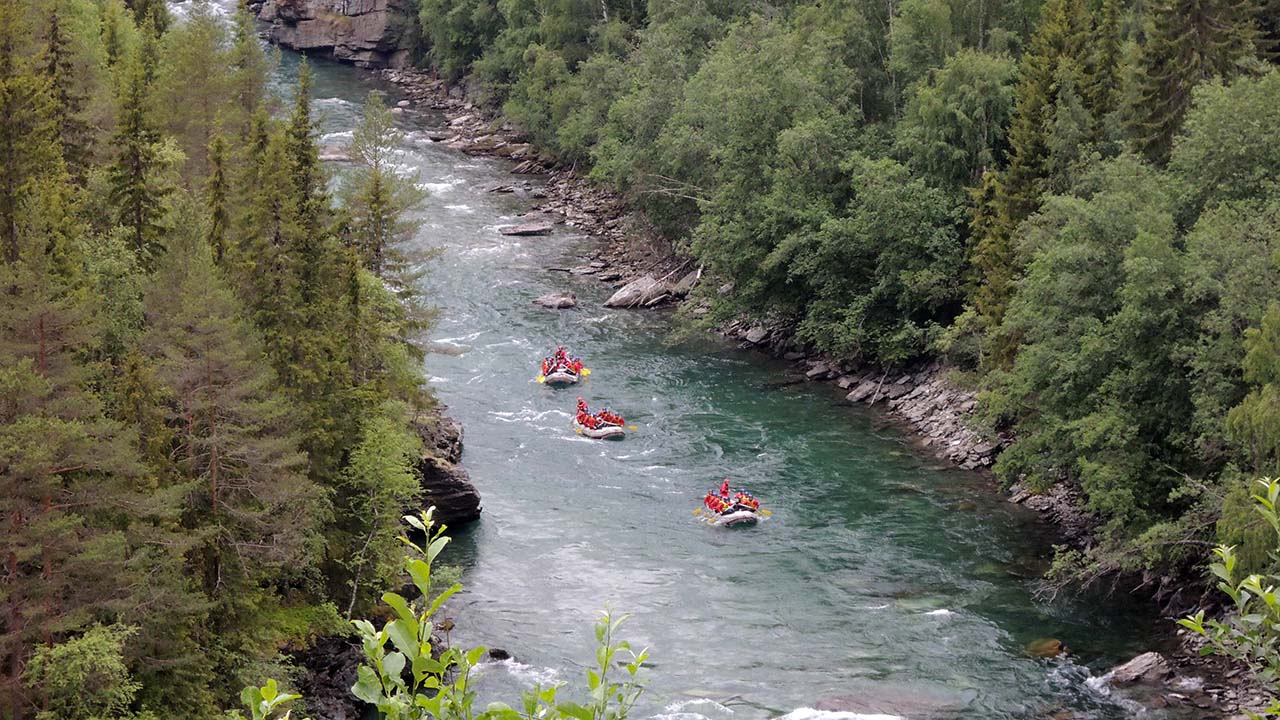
left=185, top=0, right=1203, bottom=720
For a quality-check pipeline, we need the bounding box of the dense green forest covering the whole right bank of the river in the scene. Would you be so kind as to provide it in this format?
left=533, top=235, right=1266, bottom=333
left=407, top=0, right=1280, bottom=594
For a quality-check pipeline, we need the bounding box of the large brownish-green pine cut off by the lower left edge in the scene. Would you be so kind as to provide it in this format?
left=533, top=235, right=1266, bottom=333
left=0, top=243, right=150, bottom=717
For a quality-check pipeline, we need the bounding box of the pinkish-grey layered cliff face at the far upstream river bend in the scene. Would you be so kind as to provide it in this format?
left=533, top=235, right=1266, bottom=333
left=257, top=0, right=415, bottom=68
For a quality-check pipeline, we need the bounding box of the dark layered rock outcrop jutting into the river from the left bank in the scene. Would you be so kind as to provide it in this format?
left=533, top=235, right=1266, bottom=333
left=413, top=414, right=480, bottom=529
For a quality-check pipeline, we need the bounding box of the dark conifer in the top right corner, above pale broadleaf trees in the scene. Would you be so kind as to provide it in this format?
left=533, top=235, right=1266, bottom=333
left=1129, top=0, right=1258, bottom=164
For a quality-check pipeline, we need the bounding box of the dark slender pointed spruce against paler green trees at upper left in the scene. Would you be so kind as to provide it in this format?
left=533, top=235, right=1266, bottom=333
left=110, top=49, right=172, bottom=265
